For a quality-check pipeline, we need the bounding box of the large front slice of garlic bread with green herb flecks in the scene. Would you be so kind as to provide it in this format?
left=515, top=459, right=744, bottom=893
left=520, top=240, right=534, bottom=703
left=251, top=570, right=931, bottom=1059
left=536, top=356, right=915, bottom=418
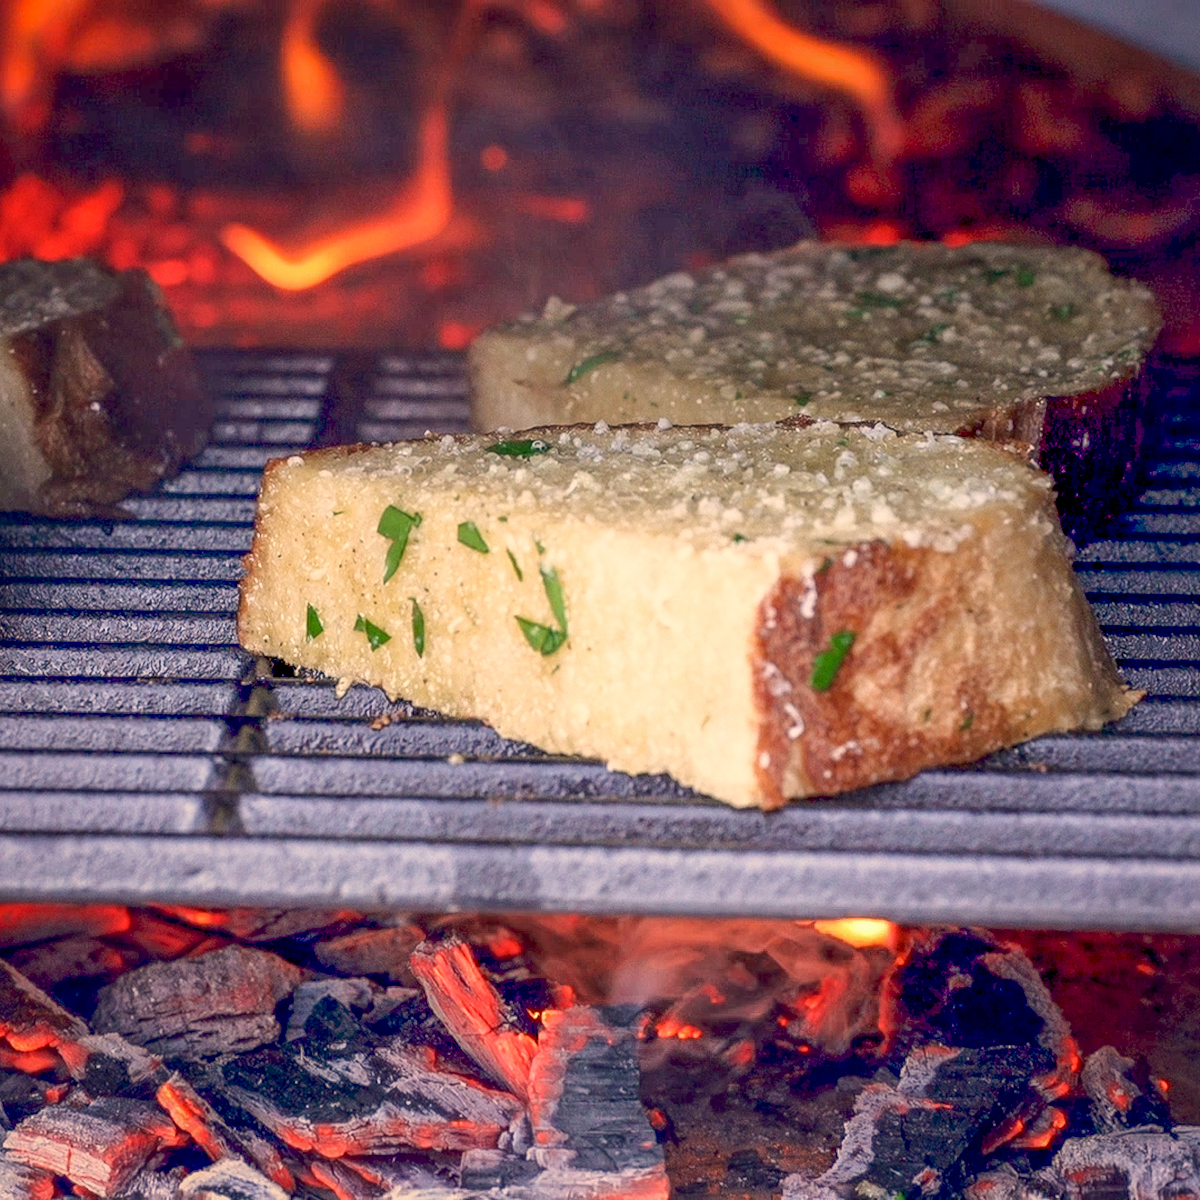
left=239, top=421, right=1133, bottom=806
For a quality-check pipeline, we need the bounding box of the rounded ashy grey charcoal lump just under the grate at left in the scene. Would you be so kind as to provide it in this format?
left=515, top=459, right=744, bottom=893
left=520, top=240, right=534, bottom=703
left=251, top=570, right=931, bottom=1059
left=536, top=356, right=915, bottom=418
left=92, top=946, right=301, bottom=1058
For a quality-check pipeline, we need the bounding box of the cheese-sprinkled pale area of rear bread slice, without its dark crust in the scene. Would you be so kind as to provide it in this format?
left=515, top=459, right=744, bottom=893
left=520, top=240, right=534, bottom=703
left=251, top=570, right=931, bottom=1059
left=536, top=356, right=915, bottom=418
left=468, top=242, right=1162, bottom=436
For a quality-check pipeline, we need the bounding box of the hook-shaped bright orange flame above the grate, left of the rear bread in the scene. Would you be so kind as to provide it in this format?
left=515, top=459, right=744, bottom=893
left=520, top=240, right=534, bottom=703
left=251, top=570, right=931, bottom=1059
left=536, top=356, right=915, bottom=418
left=221, top=103, right=454, bottom=292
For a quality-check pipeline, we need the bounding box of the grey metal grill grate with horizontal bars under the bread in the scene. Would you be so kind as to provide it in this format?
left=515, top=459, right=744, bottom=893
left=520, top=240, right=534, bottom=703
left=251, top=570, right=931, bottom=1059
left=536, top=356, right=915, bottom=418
left=0, top=352, right=1200, bottom=930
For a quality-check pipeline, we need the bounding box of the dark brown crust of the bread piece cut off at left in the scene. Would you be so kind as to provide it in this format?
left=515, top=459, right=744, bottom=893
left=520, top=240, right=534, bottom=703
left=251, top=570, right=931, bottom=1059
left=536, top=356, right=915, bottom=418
left=10, top=264, right=212, bottom=516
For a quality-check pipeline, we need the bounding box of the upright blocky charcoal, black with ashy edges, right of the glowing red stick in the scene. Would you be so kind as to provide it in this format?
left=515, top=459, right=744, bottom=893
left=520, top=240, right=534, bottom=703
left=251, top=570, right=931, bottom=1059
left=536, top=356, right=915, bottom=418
left=529, top=1006, right=667, bottom=1195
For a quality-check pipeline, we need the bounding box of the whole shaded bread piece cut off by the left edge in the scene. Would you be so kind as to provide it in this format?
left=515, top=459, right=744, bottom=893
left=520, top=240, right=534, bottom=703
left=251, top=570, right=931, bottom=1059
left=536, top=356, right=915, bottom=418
left=0, top=258, right=212, bottom=516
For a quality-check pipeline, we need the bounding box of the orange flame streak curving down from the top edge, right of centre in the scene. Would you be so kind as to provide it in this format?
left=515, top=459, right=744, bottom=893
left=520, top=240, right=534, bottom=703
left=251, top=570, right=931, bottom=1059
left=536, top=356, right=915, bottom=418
left=708, top=0, right=905, bottom=162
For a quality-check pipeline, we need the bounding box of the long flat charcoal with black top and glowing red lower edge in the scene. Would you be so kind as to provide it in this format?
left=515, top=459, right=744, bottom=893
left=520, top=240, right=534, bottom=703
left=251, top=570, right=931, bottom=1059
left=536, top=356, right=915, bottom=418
left=221, top=1042, right=521, bottom=1158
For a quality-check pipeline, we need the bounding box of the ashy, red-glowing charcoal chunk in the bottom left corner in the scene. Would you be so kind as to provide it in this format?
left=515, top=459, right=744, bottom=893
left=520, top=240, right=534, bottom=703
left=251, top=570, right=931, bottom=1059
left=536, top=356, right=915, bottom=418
left=4, top=1096, right=181, bottom=1196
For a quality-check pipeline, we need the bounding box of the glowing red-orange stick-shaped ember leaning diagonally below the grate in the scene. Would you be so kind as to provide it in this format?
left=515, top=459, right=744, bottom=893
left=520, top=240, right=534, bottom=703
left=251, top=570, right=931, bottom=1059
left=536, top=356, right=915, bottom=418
left=409, top=936, right=538, bottom=1100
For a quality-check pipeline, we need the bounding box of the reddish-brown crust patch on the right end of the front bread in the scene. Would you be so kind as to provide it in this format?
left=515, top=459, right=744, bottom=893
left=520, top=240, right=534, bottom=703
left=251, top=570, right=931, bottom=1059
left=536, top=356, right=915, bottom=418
left=755, top=541, right=1019, bottom=809
